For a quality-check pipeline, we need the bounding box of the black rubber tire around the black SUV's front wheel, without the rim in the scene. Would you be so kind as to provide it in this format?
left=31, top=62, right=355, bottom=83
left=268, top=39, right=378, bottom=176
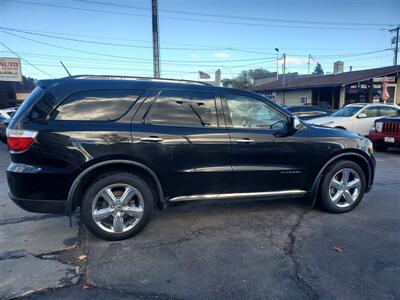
left=320, top=160, right=366, bottom=213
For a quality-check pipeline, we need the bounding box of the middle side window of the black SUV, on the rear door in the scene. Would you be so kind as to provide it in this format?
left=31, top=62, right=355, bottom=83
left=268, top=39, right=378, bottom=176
left=146, top=91, right=218, bottom=127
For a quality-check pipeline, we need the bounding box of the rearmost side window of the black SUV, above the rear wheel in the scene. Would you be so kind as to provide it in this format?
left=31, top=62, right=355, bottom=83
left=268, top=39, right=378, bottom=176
left=50, top=90, right=143, bottom=121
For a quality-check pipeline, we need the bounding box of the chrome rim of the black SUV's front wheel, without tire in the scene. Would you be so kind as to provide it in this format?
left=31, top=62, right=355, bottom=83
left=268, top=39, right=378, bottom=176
left=329, top=168, right=361, bottom=208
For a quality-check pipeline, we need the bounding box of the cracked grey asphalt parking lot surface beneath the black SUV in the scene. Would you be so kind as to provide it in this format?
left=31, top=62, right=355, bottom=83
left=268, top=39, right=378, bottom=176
left=0, top=145, right=400, bottom=299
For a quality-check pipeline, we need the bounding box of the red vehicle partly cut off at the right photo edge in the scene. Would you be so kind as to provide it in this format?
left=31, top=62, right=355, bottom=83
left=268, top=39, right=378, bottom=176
left=368, top=116, right=400, bottom=151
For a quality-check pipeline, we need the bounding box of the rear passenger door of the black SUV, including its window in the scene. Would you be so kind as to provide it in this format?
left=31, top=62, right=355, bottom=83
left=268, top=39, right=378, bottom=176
left=132, top=90, right=232, bottom=200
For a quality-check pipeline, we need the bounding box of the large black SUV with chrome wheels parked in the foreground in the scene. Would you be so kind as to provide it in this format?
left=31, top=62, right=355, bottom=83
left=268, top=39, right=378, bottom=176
left=7, top=76, right=375, bottom=240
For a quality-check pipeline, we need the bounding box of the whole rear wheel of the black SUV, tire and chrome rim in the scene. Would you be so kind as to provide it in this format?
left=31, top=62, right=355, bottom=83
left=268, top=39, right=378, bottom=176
left=81, top=173, right=154, bottom=240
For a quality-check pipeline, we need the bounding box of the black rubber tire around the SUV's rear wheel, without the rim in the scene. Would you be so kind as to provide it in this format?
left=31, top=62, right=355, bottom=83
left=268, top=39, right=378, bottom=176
left=81, top=172, right=154, bottom=241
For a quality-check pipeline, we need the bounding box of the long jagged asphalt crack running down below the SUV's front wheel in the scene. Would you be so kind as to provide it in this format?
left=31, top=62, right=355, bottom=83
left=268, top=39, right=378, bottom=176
left=284, top=209, right=319, bottom=299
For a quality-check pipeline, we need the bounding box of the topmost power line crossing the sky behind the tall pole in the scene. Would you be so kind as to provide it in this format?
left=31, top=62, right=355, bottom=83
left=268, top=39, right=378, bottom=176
left=3, top=0, right=387, bottom=30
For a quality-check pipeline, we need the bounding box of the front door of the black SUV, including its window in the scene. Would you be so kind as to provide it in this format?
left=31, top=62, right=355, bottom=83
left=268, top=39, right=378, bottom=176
left=223, top=94, right=310, bottom=193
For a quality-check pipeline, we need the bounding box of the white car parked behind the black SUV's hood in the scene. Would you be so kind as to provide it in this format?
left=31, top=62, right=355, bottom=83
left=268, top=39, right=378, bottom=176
left=306, top=103, right=400, bottom=136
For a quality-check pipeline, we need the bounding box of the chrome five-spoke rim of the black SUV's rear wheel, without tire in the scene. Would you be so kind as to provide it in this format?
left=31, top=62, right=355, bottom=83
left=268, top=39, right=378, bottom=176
left=92, top=183, right=144, bottom=233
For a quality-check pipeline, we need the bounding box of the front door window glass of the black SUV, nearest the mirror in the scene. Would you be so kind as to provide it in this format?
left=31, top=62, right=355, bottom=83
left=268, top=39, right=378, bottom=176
left=225, top=94, right=288, bottom=129
